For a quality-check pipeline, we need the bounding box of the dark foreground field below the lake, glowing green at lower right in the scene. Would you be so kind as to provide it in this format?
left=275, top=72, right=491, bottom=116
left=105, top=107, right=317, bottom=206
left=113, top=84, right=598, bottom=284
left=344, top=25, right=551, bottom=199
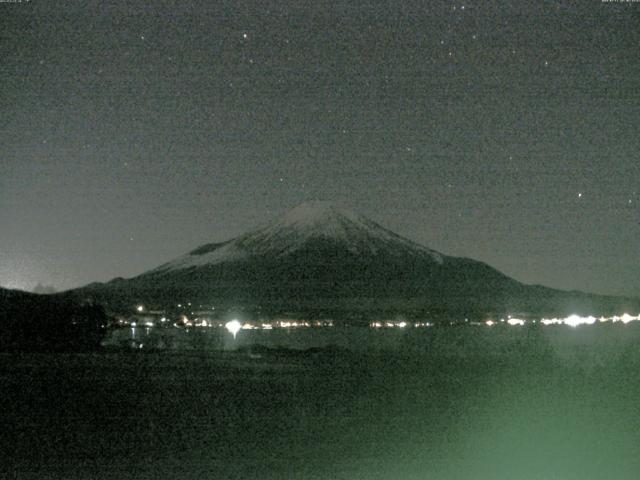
left=0, top=328, right=640, bottom=480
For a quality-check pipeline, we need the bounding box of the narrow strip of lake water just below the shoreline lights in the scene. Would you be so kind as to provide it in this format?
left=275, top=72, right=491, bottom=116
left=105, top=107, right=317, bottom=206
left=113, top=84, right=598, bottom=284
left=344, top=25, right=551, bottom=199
left=103, top=322, right=640, bottom=358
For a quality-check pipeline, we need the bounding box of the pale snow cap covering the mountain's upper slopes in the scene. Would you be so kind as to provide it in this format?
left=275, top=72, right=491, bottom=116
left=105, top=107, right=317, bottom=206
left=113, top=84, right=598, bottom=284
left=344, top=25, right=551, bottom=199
left=149, top=202, right=444, bottom=274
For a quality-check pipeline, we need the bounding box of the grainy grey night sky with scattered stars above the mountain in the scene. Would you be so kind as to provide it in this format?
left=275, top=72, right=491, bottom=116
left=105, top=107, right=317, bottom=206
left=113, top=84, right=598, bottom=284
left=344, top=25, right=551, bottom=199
left=0, top=0, right=640, bottom=296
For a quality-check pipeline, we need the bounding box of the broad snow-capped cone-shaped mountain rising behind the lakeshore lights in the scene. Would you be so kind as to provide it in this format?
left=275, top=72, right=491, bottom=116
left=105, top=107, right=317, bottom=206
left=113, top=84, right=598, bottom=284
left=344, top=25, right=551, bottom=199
left=72, top=202, right=637, bottom=318
